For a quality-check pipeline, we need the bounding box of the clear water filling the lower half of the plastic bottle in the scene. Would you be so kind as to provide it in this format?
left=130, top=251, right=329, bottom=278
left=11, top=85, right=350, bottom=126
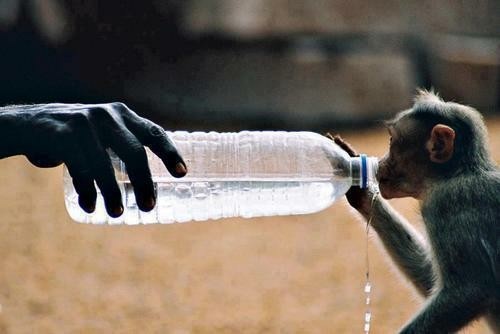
left=66, top=178, right=350, bottom=224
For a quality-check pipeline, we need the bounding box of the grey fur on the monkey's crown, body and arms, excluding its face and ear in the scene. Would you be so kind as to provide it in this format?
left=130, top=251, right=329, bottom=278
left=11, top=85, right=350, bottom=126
left=361, top=92, right=500, bottom=334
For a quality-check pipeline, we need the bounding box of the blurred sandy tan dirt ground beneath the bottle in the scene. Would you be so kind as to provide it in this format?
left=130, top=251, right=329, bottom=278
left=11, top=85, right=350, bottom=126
left=0, top=118, right=500, bottom=334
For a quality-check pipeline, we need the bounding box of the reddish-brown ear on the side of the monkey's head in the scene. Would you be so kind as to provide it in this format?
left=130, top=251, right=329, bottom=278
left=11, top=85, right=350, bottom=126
left=426, top=124, right=455, bottom=164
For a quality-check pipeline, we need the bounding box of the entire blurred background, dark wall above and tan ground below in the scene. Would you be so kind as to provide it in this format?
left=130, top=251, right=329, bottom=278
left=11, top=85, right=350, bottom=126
left=0, top=0, right=500, bottom=333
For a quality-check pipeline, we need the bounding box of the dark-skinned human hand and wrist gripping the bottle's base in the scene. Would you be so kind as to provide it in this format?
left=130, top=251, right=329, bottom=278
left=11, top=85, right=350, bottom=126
left=0, top=103, right=187, bottom=217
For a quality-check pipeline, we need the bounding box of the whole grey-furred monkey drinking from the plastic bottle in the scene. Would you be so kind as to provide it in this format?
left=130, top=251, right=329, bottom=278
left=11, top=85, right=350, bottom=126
left=334, top=90, right=500, bottom=334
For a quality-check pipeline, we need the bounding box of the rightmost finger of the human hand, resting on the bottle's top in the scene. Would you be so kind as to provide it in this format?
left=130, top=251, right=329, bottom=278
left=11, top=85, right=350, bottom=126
left=125, top=113, right=187, bottom=177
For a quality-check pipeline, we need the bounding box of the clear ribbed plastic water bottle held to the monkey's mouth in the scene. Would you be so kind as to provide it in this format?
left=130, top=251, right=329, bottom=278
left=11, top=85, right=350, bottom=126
left=64, top=131, right=378, bottom=224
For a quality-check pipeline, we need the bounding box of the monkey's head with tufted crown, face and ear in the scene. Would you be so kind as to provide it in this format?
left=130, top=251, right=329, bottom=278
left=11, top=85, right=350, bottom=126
left=377, top=91, right=494, bottom=199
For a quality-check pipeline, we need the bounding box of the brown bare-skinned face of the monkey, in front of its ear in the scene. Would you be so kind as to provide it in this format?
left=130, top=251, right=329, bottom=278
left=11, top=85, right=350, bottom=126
left=377, top=112, right=427, bottom=199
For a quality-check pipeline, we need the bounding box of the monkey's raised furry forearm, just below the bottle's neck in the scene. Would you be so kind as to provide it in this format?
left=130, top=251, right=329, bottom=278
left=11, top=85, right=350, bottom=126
left=360, top=197, right=435, bottom=297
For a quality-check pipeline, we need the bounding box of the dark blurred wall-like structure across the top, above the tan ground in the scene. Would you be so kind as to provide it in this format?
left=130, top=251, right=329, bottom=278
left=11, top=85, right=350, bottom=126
left=0, top=0, right=500, bottom=130
